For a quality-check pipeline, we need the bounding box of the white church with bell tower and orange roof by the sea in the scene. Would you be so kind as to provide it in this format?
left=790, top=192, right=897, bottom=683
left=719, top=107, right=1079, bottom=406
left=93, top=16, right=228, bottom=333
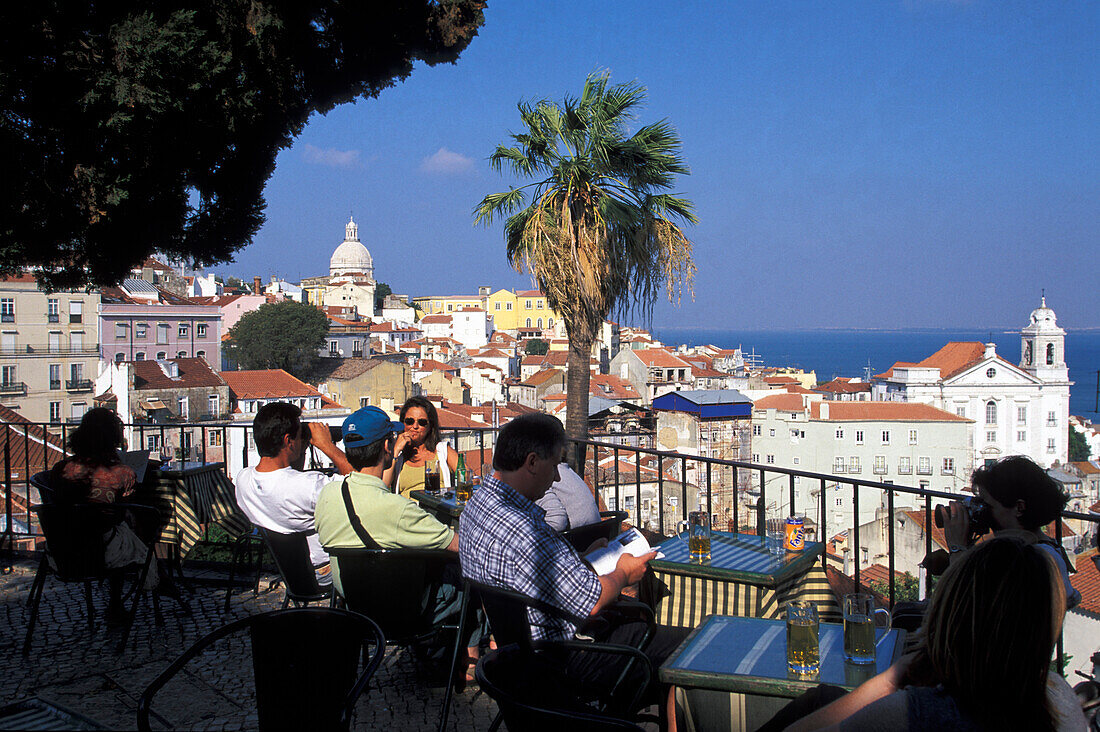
left=871, top=296, right=1073, bottom=468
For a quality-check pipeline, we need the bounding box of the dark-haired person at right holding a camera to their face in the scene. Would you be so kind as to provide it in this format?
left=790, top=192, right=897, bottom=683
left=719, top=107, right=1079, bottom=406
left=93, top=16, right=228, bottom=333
left=936, top=455, right=1081, bottom=608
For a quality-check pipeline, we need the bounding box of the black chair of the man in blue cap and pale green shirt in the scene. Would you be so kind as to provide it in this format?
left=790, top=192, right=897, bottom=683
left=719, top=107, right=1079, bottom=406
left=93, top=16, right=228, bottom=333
left=326, top=547, right=469, bottom=730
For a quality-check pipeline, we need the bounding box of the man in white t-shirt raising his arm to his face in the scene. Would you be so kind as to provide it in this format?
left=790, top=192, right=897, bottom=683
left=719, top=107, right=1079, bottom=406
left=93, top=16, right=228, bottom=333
left=237, top=402, right=351, bottom=584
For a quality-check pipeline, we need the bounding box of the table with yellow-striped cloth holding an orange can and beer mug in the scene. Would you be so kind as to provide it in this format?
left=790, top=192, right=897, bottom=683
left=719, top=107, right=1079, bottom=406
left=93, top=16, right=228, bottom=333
left=649, top=532, right=840, bottom=627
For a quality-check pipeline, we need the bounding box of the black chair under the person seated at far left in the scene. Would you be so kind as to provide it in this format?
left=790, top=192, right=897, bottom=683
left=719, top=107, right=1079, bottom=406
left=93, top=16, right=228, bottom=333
left=23, top=503, right=164, bottom=656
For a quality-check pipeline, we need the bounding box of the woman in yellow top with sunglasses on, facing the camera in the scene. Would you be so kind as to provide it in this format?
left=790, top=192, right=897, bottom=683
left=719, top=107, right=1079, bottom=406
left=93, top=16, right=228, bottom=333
left=382, top=396, right=459, bottom=498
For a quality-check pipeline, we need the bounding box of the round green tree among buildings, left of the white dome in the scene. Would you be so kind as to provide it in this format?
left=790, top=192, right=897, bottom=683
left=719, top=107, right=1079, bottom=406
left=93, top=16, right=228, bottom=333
left=226, top=301, right=329, bottom=379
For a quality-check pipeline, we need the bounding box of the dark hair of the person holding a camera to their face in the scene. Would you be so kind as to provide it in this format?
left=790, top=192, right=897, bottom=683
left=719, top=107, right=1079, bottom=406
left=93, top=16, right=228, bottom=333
left=971, top=455, right=1068, bottom=531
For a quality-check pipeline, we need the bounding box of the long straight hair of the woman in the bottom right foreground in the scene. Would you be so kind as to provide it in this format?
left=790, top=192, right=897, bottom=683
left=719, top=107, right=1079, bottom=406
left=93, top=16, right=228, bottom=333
left=910, top=536, right=1060, bottom=730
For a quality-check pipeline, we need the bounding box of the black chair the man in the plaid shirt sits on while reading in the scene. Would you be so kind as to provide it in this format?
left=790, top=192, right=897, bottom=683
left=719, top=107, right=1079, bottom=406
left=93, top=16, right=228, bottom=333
left=466, top=580, right=657, bottom=731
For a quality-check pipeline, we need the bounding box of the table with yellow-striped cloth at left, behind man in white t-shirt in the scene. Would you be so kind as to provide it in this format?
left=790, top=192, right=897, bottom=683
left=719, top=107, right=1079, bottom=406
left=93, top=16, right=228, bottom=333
left=154, top=462, right=252, bottom=556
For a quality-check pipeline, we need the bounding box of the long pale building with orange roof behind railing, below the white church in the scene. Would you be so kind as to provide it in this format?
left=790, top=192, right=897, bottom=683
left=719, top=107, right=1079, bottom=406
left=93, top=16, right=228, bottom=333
left=751, top=394, right=974, bottom=531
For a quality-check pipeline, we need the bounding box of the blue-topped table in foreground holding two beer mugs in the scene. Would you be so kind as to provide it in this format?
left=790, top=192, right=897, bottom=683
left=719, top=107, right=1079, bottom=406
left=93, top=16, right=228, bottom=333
left=658, top=615, right=905, bottom=730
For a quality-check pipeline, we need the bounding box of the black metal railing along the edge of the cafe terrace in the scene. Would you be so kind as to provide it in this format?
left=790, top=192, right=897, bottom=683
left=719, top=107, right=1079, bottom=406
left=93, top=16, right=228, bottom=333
left=0, top=420, right=1100, bottom=604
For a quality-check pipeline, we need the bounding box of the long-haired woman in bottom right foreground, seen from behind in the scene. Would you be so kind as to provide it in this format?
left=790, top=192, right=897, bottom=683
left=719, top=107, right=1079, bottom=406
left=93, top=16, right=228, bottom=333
left=773, top=536, right=1085, bottom=732
